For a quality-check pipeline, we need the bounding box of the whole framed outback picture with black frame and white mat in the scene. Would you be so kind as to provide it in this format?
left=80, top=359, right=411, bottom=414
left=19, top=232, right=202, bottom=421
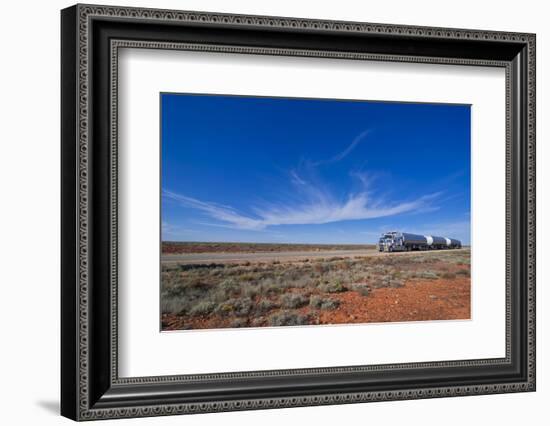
left=61, top=5, right=535, bottom=420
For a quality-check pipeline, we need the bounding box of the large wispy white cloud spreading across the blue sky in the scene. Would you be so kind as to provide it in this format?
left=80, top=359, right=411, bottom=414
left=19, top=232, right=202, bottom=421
left=163, top=130, right=441, bottom=231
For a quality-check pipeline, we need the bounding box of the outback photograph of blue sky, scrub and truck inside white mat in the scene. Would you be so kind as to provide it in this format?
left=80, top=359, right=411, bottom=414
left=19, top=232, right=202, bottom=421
left=160, top=93, right=471, bottom=331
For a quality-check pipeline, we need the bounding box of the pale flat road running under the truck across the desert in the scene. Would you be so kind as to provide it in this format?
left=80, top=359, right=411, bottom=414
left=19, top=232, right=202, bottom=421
left=161, top=249, right=470, bottom=263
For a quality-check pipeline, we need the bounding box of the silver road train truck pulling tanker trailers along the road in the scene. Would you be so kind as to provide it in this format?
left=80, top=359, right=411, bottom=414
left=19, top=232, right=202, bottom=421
left=378, top=231, right=462, bottom=252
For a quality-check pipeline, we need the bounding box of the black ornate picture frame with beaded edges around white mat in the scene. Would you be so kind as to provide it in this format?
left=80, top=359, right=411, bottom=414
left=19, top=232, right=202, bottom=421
left=61, top=5, right=535, bottom=420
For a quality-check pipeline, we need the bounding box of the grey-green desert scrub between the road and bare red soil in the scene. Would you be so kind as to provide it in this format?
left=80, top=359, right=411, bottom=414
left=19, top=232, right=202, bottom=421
left=160, top=246, right=470, bottom=328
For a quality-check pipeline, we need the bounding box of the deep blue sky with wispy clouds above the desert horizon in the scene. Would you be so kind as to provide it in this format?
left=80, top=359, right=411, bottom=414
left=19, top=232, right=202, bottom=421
left=161, top=94, right=470, bottom=244
